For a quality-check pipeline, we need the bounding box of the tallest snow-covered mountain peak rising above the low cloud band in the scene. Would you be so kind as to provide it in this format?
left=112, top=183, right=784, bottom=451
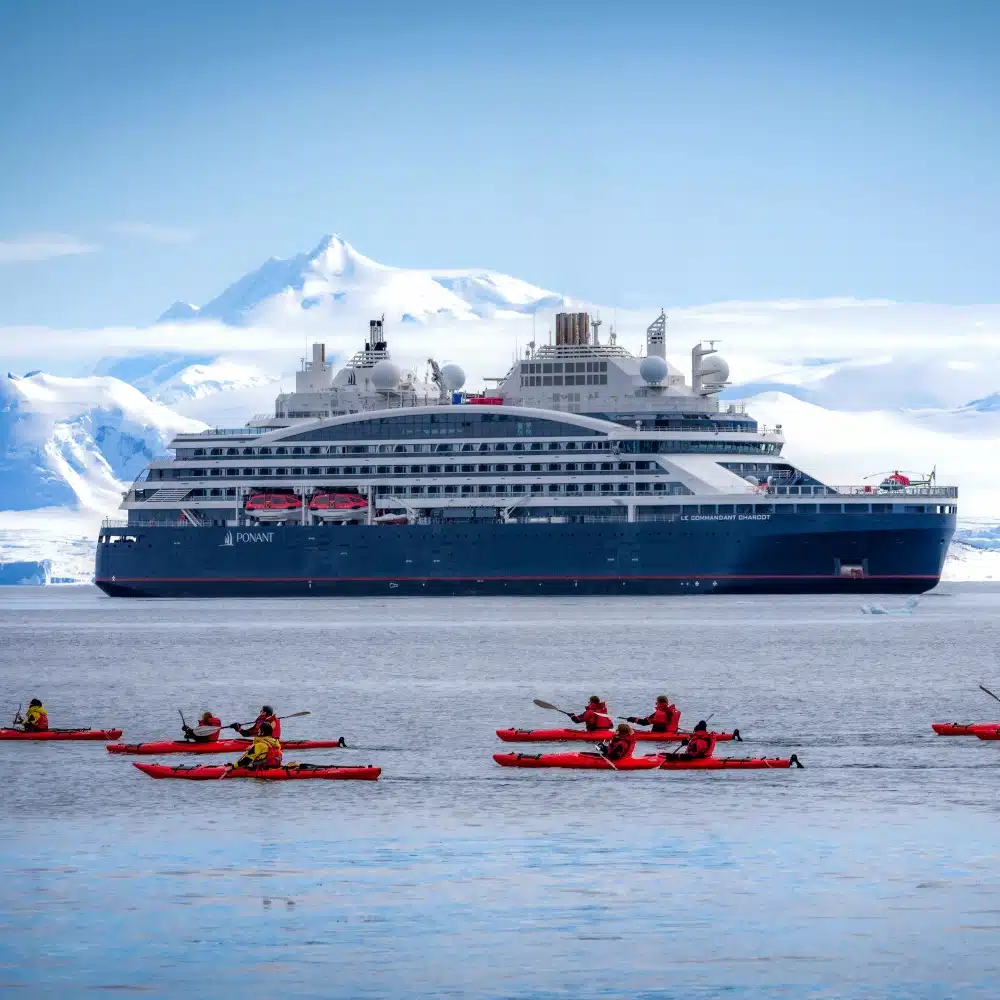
left=159, top=236, right=571, bottom=326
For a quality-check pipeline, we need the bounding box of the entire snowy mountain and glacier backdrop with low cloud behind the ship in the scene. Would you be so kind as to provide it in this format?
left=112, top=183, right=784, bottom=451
left=0, top=230, right=1000, bottom=581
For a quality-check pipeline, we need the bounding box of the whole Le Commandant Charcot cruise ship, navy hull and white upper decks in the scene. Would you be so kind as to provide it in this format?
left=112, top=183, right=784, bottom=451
left=95, top=313, right=958, bottom=597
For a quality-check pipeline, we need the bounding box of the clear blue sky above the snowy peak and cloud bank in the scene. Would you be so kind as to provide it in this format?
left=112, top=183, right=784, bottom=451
left=0, top=0, right=1000, bottom=326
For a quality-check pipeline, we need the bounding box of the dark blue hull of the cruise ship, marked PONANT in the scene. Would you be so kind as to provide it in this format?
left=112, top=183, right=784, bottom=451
left=96, top=512, right=955, bottom=597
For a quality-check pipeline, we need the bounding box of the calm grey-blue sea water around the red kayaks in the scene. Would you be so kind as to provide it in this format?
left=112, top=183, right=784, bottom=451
left=0, top=585, right=1000, bottom=1000
